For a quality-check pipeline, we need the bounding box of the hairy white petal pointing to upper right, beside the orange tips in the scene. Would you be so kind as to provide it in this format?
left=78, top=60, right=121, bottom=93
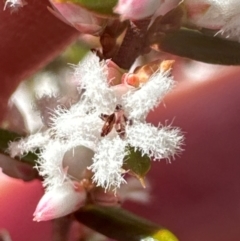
left=123, top=70, right=174, bottom=119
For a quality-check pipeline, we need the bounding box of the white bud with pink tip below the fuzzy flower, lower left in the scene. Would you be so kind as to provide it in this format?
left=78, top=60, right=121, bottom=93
left=33, top=182, right=86, bottom=222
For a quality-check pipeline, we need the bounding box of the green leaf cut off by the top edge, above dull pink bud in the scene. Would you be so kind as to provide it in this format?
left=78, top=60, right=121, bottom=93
left=59, top=0, right=118, bottom=16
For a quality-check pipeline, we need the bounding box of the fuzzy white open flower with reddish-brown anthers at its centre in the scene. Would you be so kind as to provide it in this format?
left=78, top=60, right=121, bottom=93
left=9, top=53, right=183, bottom=220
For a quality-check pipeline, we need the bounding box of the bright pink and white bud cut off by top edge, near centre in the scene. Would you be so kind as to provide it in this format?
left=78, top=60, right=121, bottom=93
left=114, top=0, right=163, bottom=20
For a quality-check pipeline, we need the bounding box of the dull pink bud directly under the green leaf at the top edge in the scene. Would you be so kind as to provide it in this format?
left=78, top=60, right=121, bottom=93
left=49, top=0, right=107, bottom=35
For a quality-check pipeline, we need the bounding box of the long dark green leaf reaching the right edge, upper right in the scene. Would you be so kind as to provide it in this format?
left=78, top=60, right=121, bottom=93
left=149, top=28, right=240, bottom=65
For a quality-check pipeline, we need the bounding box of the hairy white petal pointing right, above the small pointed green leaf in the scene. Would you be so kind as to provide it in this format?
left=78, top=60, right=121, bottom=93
left=127, top=123, right=183, bottom=160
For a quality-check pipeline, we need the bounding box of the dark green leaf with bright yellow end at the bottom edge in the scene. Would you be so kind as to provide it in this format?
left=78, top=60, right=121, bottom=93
left=75, top=205, right=178, bottom=241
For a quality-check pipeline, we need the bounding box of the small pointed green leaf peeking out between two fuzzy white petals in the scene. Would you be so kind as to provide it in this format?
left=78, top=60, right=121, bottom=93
left=123, top=147, right=151, bottom=185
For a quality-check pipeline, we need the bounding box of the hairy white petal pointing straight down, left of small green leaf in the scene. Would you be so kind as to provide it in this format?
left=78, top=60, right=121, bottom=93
left=89, top=136, right=127, bottom=190
